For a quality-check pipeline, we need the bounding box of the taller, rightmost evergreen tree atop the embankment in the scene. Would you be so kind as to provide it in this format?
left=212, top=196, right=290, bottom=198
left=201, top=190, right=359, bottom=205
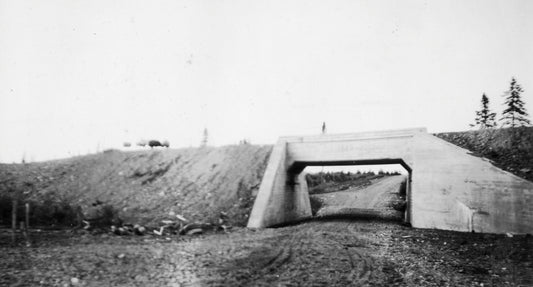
left=500, top=78, right=530, bottom=128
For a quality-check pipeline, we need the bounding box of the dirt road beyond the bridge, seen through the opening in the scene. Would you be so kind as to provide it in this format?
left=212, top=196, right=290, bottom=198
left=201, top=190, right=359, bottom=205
left=312, top=175, right=405, bottom=219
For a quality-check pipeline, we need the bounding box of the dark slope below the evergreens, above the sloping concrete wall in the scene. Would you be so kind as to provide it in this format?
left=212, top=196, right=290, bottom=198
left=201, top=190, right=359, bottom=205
left=435, top=127, right=533, bottom=181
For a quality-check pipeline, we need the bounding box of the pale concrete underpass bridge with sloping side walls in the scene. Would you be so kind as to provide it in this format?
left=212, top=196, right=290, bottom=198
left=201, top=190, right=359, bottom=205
left=248, top=128, right=533, bottom=233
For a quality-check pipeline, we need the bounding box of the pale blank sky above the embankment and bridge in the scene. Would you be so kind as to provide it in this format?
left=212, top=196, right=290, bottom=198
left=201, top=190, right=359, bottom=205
left=0, top=0, right=533, bottom=163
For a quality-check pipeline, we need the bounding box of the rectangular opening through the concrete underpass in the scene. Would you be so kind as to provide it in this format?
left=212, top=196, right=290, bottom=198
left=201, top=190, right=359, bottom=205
left=287, top=159, right=412, bottom=223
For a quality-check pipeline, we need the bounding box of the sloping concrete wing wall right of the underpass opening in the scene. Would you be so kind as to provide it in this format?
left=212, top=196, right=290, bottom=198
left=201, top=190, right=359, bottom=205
left=411, top=134, right=533, bottom=233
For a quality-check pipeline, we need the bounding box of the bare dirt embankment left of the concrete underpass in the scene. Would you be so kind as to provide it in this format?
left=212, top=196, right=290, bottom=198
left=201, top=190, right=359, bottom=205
left=0, top=145, right=271, bottom=228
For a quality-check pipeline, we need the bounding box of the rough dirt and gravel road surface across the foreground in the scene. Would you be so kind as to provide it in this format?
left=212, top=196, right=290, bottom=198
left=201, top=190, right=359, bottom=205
left=0, top=219, right=533, bottom=286
